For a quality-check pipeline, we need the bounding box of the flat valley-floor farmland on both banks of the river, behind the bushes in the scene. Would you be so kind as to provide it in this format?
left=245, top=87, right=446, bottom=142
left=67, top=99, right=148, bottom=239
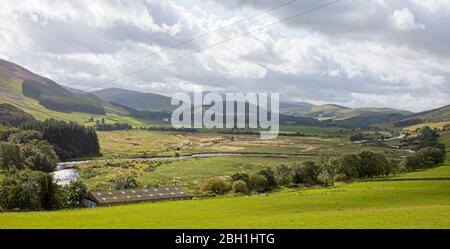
left=78, top=130, right=408, bottom=190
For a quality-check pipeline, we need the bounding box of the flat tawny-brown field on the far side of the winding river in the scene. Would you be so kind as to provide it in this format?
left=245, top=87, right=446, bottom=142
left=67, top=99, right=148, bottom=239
left=98, top=130, right=408, bottom=158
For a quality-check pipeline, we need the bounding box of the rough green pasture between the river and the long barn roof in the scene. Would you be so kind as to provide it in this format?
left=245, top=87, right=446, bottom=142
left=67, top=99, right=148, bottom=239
left=79, top=156, right=313, bottom=190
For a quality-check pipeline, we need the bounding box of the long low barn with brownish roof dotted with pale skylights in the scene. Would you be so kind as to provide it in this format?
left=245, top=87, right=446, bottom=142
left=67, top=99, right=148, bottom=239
left=83, top=187, right=193, bottom=207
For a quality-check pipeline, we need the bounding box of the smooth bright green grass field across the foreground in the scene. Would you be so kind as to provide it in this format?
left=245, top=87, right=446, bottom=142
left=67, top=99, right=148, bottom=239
left=0, top=181, right=450, bottom=228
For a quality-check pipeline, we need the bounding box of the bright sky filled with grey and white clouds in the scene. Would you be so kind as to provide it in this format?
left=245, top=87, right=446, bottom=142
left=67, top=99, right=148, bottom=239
left=0, top=0, right=450, bottom=111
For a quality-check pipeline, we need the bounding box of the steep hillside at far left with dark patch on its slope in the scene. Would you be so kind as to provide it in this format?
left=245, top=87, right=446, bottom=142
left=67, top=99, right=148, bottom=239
left=0, top=60, right=153, bottom=126
